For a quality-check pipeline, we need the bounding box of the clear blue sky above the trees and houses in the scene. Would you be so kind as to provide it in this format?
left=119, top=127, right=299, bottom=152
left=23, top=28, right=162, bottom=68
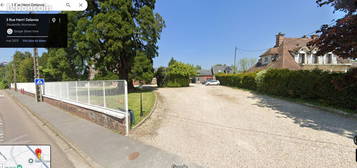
left=0, top=0, right=342, bottom=68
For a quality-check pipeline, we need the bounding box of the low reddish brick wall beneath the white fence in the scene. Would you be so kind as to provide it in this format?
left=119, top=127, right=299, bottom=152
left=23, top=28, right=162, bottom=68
left=15, top=89, right=126, bottom=135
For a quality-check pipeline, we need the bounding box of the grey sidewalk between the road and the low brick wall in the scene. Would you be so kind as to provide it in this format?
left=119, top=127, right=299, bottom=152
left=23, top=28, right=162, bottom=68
left=8, top=91, right=199, bottom=168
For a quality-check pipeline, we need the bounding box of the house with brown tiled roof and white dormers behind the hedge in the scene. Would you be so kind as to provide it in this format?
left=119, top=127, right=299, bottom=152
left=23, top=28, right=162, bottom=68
left=248, top=33, right=352, bottom=72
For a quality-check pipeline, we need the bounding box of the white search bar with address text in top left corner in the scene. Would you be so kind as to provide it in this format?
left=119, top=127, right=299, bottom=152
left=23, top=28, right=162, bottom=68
left=0, top=0, right=88, bottom=12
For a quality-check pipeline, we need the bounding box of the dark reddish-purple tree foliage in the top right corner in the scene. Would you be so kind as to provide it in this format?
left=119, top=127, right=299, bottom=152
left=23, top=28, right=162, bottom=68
left=309, top=0, right=357, bottom=58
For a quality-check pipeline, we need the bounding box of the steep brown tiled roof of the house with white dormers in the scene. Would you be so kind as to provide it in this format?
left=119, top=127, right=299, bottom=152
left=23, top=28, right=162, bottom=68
left=248, top=37, right=312, bottom=72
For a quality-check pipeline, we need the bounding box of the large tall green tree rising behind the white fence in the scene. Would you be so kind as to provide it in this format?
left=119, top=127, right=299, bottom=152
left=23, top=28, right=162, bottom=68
left=74, top=0, right=165, bottom=88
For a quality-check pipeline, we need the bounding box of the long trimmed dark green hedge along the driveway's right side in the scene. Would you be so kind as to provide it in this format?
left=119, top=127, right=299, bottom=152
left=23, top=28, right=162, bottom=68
left=216, top=69, right=357, bottom=111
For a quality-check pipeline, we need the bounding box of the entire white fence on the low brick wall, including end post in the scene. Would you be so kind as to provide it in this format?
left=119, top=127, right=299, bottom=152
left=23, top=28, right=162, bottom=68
left=11, top=80, right=128, bottom=133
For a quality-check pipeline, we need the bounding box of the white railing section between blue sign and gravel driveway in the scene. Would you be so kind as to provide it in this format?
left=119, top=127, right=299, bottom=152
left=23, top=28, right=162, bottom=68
left=43, top=80, right=127, bottom=112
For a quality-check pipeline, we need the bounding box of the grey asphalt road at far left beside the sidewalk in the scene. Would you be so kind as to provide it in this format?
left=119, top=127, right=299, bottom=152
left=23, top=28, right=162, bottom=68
left=0, top=90, right=73, bottom=168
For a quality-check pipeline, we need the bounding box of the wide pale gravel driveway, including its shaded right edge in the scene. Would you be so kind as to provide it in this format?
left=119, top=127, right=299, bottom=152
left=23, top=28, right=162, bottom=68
left=132, top=85, right=357, bottom=168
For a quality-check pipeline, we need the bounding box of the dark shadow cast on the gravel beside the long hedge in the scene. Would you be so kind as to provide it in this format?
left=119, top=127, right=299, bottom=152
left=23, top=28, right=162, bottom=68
left=248, top=93, right=357, bottom=139
